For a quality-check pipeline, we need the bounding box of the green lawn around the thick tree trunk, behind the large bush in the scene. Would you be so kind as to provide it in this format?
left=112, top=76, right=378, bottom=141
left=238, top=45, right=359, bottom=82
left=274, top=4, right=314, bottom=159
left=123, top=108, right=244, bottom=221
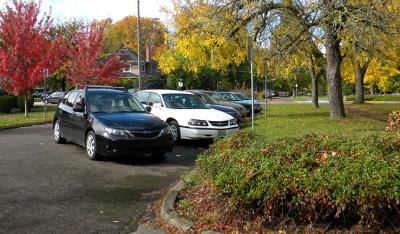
left=247, top=104, right=400, bottom=140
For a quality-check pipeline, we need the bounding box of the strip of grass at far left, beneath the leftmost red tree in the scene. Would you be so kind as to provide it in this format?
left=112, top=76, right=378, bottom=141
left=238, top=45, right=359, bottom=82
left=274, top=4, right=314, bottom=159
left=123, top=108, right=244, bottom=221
left=0, top=107, right=55, bottom=129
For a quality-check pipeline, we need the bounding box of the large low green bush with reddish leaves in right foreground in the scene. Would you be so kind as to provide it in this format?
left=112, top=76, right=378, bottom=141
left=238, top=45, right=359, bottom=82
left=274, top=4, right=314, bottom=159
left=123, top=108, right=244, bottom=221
left=197, top=132, right=400, bottom=225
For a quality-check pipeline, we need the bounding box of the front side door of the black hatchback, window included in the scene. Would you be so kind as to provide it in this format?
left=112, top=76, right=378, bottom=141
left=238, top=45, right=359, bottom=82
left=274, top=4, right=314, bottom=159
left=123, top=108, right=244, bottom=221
left=71, top=92, right=86, bottom=144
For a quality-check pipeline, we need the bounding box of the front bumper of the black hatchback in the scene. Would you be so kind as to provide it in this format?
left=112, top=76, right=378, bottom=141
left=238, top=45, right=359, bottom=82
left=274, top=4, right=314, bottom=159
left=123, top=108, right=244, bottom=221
left=96, top=134, right=174, bottom=156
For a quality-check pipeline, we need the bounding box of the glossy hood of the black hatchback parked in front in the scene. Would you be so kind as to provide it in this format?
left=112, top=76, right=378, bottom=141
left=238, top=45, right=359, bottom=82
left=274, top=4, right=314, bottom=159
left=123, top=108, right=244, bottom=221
left=92, top=113, right=167, bottom=130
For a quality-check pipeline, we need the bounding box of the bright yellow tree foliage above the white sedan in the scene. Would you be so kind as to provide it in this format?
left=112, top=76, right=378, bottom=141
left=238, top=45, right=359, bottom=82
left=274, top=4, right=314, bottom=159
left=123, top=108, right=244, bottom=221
left=159, top=1, right=247, bottom=74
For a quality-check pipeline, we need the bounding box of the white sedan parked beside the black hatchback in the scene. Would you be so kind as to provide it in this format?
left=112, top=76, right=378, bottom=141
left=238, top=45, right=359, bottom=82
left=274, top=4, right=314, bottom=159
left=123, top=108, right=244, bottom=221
left=134, top=90, right=239, bottom=141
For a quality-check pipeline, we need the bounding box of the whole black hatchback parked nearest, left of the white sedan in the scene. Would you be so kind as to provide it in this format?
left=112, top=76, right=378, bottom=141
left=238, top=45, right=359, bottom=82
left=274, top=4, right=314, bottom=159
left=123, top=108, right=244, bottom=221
left=53, top=87, right=173, bottom=160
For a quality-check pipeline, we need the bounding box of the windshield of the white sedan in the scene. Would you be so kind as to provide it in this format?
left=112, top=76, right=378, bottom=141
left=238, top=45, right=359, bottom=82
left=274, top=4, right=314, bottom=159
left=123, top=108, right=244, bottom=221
left=162, top=93, right=208, bottom=109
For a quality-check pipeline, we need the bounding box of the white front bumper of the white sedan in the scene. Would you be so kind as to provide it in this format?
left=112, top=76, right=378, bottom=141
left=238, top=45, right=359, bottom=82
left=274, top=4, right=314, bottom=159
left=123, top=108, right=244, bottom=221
left=180, top=126, right=239, bottom=139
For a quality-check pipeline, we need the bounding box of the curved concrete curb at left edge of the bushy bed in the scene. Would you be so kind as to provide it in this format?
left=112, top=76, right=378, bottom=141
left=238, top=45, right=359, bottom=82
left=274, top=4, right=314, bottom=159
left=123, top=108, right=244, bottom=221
left=160, top=180, right=193, bottom=232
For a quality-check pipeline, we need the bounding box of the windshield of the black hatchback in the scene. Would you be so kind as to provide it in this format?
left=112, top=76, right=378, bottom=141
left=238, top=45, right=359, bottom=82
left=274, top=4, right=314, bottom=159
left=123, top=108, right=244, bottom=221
left=88, top=92, right=145, bottom=113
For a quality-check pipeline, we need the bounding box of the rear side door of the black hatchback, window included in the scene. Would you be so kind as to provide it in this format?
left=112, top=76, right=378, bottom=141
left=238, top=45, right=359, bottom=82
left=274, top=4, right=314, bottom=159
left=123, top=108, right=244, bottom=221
left=61, top=91, right=79, bottom=141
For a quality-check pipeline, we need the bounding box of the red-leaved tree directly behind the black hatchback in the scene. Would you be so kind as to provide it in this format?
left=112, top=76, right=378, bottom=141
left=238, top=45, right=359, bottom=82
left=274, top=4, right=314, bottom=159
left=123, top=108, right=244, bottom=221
left=66, top=22, right=125, bottom=85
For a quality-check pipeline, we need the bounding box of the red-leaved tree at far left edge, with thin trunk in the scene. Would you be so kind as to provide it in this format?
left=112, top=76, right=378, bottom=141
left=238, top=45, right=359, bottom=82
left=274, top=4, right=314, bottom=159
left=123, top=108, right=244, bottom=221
left=0, top=0, right=61, bottom=115
